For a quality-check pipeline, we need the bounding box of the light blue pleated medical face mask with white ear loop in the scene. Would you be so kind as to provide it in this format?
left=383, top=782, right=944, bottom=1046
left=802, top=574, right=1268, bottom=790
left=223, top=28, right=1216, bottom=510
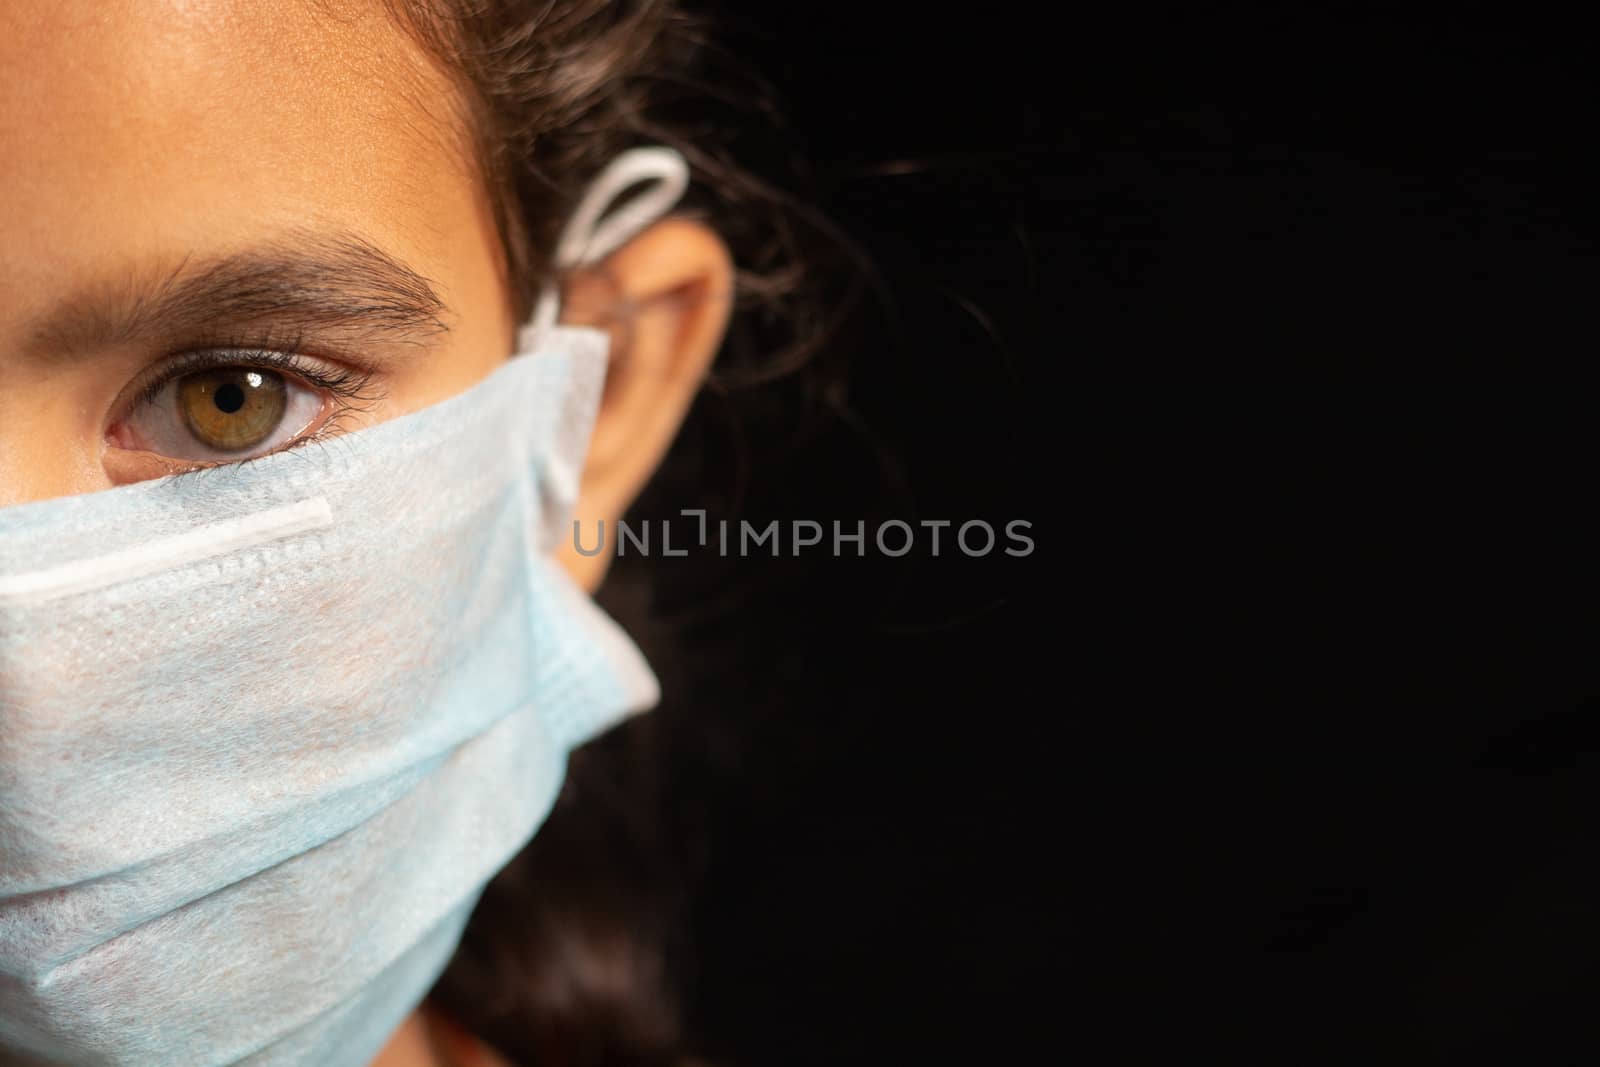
left=0, top=150, right=685, bottom=1067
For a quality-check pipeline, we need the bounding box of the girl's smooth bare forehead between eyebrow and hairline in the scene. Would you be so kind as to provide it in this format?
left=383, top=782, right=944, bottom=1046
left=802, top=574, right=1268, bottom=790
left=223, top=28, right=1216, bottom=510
left=0, top=0, right=474, bottom=325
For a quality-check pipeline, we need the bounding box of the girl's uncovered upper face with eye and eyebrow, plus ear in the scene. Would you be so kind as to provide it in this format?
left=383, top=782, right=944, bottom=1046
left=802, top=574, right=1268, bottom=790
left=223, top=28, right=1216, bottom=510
left=0, top=0, right=731, bottom=591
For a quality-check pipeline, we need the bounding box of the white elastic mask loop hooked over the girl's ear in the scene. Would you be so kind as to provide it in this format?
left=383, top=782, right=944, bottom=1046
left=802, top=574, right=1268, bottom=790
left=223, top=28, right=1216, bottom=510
left=517, top=147, right=690, bottom=352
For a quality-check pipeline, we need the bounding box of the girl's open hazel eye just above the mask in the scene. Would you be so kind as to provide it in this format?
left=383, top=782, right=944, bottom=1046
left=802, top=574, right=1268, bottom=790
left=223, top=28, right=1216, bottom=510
left=106, top=347, right=380, bottom=466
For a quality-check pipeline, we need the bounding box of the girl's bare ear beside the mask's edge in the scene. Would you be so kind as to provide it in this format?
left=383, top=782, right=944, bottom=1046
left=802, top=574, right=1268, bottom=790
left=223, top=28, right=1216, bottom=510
left=557, top=219, right=733, bottom=592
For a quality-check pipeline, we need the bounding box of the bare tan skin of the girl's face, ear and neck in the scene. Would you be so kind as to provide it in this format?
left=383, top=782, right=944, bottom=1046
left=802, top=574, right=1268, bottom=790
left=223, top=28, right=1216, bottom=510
left=0, top=0, right=733, bottom=1067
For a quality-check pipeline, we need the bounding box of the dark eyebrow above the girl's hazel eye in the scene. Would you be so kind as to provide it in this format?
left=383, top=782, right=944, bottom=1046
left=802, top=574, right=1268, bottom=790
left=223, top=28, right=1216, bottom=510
left=24, top=232, right=450, bottom=357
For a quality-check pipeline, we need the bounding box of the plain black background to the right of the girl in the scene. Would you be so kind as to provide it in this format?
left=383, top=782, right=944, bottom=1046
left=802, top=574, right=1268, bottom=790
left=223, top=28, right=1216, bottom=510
left=665, top=3, right=1600, bottom=1065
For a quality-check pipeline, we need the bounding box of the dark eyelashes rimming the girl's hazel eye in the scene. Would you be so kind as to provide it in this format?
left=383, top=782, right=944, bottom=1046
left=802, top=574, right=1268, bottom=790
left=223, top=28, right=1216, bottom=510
left=122, top=336, right=382, bottom=466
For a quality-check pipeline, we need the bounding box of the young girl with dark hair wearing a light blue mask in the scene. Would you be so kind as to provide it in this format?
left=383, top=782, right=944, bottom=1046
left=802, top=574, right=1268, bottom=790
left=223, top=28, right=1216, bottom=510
left=0, top=0, right=825, bottom=1067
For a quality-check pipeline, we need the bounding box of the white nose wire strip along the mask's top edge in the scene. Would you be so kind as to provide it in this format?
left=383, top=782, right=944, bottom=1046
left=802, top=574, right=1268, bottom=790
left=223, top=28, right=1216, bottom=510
left=0, top=496, right=333, bottom=605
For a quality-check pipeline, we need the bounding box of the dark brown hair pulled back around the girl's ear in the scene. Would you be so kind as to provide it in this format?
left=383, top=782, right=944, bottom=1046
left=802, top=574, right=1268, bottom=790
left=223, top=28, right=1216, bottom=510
left=376, top=0, right=867, bottom=1067
